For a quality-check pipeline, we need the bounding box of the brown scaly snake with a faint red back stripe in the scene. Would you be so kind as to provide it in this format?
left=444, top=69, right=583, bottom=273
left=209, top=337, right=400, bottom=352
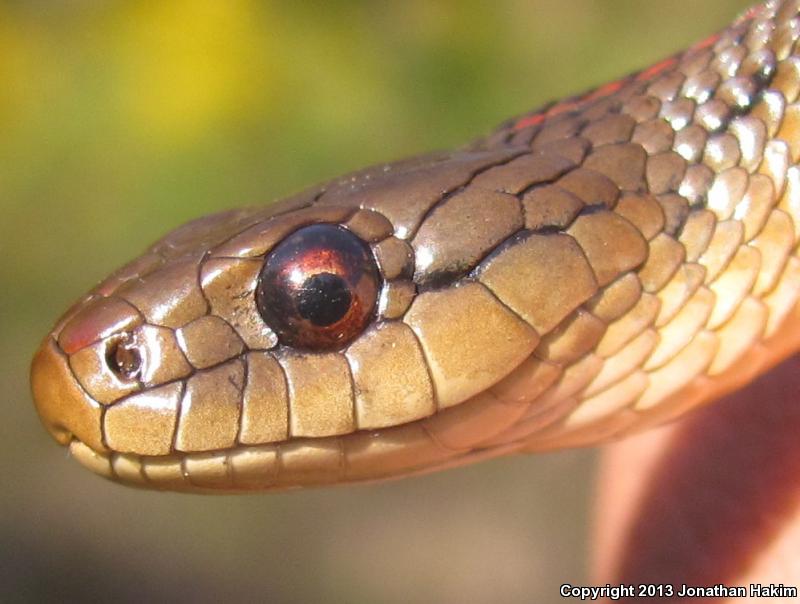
left=31, top=0, right=800, bottom=493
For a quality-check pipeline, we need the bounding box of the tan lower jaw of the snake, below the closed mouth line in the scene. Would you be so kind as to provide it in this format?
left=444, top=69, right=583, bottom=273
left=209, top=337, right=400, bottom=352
left=69, top=434, right=520, bottom=495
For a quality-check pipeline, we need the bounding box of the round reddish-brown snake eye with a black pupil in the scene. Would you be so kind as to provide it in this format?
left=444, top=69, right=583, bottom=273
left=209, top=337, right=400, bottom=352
left=256, top=224, right=379, bottom=350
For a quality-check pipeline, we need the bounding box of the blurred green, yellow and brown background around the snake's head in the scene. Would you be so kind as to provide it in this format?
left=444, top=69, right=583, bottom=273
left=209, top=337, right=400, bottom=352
left=0, top=0, right=747, bottom=603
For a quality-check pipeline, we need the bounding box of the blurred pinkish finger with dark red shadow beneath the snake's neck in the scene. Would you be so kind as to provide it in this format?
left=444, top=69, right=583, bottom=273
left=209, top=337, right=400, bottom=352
left=594, top=356, right=800, bottom=589
